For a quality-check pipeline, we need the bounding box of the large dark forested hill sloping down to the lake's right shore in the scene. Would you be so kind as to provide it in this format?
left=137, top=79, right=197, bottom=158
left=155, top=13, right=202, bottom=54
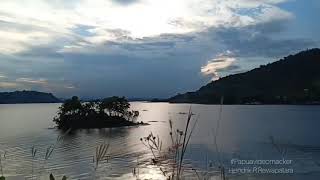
left=168, top=48, right=320, bottom=104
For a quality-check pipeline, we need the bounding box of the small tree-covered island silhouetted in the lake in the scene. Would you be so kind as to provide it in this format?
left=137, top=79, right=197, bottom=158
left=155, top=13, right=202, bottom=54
left=53, top=96, right=144, bottom=130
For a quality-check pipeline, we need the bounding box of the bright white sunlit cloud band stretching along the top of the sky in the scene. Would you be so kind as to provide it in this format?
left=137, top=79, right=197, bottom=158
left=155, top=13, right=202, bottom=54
left=0, top=0, right=291, bottom=54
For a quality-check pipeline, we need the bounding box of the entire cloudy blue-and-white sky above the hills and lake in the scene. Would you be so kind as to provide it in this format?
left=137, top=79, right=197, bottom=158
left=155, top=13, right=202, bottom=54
left=0, top=0, right=320, bottom=98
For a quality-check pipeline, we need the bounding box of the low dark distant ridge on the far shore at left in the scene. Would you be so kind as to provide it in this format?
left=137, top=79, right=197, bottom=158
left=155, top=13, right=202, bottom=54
left=0, top=91, right=61, bottom=104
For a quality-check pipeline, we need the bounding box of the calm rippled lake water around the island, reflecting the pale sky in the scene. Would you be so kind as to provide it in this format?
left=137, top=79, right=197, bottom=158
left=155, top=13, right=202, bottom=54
left=0, top=102, right=320, bottom=180
